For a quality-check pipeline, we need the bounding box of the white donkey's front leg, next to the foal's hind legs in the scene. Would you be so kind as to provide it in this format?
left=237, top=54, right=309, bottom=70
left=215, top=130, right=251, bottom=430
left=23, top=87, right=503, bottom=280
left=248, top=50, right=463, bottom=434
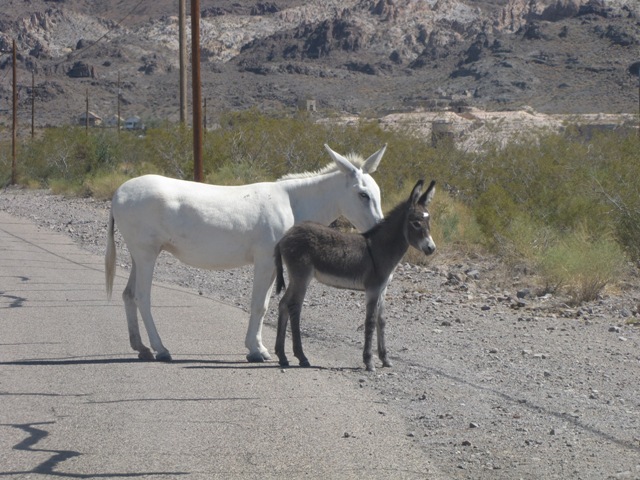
left=244, top=252, right=276, bottom=362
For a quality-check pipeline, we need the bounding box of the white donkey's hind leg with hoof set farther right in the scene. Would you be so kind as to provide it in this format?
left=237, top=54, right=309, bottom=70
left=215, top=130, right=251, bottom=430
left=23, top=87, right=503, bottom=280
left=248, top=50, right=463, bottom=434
left=132, top=253, right=171, bottom=362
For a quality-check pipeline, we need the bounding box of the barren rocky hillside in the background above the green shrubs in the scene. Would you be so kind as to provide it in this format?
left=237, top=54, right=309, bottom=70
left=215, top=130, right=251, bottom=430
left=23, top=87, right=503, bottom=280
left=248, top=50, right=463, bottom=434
left=0, top=0, right=640, bottom=125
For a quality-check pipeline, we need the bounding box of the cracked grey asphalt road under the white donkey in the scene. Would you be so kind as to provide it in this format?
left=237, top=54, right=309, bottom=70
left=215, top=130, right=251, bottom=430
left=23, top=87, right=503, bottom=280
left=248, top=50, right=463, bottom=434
left=0, top=212, right=443, bottom=480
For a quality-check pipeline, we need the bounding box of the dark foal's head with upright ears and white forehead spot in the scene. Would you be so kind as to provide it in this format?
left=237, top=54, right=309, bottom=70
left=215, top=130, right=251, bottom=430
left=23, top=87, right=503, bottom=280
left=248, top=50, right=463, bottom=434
left=406, top=180, right=436, bottom=255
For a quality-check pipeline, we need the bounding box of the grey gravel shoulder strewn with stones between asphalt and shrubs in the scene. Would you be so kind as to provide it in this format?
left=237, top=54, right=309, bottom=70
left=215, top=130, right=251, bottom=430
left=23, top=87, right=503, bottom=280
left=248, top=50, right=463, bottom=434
left=0, top=189, right=640, bottom=479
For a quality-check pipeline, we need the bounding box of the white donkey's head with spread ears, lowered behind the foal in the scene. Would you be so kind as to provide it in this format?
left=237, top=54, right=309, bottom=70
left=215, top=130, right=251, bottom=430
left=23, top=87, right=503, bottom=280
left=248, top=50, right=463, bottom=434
left=325, top=144, right=387, bottom=232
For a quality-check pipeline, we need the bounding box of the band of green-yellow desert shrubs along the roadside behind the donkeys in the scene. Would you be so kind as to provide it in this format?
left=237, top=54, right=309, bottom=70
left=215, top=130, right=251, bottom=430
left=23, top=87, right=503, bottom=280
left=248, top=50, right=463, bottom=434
left=0, top=111, right=640, bottom=304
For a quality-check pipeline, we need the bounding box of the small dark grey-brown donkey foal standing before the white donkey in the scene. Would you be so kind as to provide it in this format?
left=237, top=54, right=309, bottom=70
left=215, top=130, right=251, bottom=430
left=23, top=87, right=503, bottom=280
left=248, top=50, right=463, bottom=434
left=274, top=180, right=436, bottom=371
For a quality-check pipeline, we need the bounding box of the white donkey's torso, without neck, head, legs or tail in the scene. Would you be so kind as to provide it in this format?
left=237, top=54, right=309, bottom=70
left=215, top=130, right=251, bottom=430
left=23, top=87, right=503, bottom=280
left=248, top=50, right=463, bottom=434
left=111, top=175, right=293, bottom=269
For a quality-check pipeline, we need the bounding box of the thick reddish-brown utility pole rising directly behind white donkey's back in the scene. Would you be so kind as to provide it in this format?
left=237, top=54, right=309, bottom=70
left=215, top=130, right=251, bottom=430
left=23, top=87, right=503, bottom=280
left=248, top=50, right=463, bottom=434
left=191, top=0, right=203, bottom=182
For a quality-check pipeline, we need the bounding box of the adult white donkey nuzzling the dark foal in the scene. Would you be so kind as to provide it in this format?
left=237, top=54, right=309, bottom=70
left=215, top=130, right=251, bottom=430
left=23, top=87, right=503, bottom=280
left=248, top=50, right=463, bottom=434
left=105, top=145, right=386, bottom=362
